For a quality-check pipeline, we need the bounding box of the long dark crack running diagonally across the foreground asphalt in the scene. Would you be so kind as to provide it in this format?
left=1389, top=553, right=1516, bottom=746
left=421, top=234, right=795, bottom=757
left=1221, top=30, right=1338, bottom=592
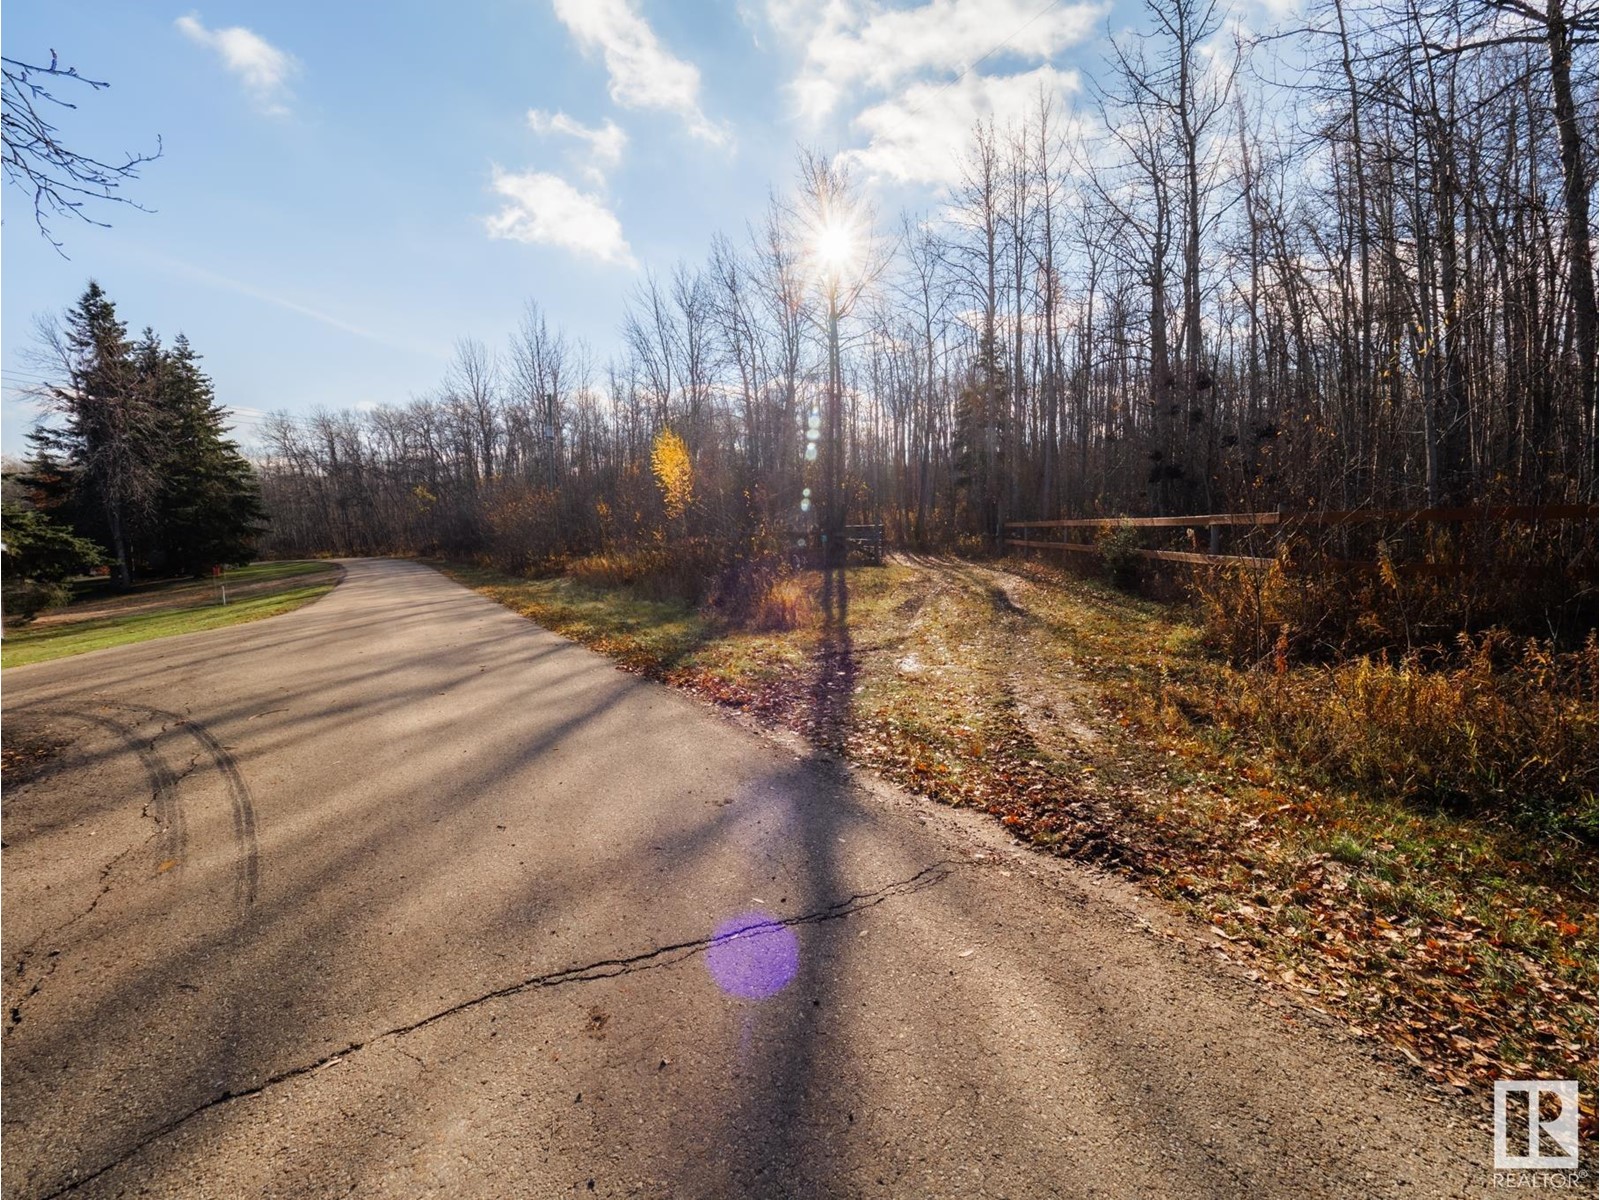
left=38, top=859, right=953, bottom=1200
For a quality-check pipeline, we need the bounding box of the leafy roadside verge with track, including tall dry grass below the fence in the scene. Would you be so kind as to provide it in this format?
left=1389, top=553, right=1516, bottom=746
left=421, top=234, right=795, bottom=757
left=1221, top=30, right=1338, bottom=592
left=441, top=558, right=1597, bottom=1122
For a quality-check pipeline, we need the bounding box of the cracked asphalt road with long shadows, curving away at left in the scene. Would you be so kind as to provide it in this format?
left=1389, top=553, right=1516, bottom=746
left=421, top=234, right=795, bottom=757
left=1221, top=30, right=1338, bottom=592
left=3, top=560, right=1490, bottom=1197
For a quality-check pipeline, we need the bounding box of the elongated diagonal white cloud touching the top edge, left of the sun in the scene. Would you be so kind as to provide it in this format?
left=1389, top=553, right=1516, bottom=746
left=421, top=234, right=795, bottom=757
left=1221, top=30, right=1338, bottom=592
left=554, top=0, right=728, bottom=146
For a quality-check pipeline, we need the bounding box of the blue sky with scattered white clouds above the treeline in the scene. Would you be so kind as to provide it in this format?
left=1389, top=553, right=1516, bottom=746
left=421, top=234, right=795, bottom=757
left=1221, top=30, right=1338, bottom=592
left=0, top=0, right=1273, bottom=454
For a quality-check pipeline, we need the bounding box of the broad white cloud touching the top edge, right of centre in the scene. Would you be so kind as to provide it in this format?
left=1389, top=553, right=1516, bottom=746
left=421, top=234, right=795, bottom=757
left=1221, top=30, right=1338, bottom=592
left=766, top=0, right=1109, bottom=120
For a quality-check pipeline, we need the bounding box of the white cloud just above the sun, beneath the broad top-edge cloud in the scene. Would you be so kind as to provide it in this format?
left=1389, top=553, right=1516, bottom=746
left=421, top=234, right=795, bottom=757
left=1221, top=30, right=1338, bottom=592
left=842, top=67, right=1080, bottom=184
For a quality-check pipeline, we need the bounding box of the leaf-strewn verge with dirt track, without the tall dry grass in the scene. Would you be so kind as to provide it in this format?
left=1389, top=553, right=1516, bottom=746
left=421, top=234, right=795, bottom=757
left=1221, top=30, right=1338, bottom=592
left=451, top=557, right=1597, bottom=1136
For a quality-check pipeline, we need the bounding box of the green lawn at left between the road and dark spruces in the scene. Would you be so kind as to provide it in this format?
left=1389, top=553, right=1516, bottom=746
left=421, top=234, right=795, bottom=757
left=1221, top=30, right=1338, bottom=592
left=0, top=562, right=339, bottom=667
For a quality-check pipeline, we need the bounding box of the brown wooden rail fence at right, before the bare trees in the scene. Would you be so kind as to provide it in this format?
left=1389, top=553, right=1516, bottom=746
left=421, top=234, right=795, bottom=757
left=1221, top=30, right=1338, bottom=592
left=1005, top=504, right=1597, bottom=574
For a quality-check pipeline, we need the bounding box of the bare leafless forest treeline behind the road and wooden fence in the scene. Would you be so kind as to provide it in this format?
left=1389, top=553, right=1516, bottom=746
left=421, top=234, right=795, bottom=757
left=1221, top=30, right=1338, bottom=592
left=259, top=0, right=1597, bottom=620
